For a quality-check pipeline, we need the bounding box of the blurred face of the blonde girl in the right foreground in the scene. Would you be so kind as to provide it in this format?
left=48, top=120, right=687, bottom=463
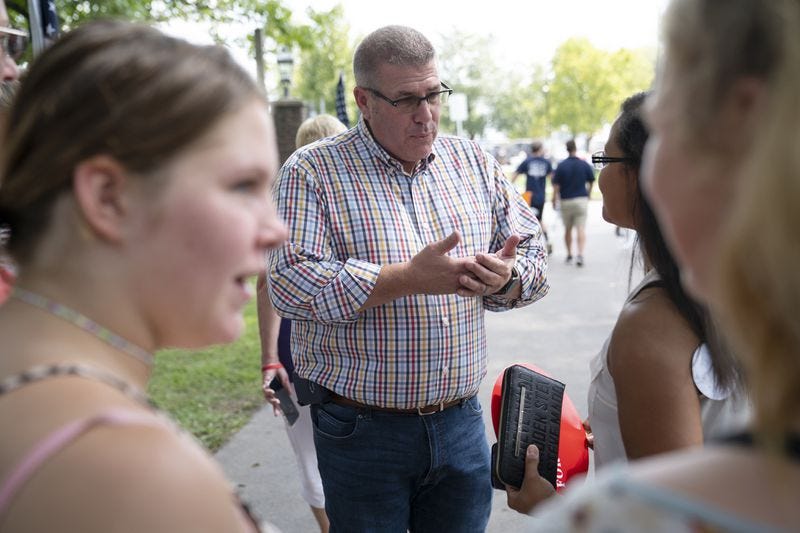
left=642, top=64, right=737, bottom=301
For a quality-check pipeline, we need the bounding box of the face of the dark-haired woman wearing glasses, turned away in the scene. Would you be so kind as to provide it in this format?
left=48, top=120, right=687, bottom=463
left=597, top=121, right=639, bottom=229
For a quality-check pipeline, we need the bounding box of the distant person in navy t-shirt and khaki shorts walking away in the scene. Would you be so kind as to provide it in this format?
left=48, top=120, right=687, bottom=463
left=552, top=139, right=594, bottom=266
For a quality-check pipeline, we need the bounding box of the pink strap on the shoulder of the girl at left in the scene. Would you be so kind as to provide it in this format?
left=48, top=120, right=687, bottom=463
left=0, top=409, right=167, bottom=517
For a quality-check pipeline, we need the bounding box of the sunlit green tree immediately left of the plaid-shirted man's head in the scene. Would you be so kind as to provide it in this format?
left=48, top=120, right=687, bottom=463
left=295, top=4, right=356, bottom=124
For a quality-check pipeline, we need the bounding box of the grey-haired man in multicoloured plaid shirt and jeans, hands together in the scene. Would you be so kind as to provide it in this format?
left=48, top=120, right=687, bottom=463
left=269, top=26, right=548, bottom=532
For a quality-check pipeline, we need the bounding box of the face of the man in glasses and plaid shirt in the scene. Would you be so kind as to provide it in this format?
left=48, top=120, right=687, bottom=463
left=355, top=62, right=442, bottom=172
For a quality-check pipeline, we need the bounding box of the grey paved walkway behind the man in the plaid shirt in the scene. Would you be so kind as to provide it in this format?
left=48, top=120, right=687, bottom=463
left=216, top=201, right=639, bottom=533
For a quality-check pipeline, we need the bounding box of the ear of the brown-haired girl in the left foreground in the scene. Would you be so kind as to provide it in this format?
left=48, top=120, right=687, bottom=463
left=72, top=155, right=130, bottom=242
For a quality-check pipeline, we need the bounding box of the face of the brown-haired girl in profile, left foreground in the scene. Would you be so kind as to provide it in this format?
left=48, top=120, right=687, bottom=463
left=129, top=100, right=287, bottom=348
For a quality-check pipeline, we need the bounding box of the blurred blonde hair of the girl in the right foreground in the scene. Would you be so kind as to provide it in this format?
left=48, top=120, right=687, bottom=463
left=666, top=0, right=800, bottom=445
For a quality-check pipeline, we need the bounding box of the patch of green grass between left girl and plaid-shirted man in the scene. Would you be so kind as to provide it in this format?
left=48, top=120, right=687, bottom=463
left=148, top=300, right=264, bottom=452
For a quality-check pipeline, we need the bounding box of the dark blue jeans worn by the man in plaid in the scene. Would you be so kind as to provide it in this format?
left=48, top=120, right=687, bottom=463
left=311, top=397, right=492, bottom=533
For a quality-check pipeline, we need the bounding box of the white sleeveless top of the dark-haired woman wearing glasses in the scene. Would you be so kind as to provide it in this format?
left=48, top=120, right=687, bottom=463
left=588, top=270, right=750, bottom=469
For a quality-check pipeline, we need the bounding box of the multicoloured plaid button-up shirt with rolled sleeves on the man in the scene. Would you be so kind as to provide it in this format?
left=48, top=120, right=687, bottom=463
left=268, top=119, right=548, bottom=408
